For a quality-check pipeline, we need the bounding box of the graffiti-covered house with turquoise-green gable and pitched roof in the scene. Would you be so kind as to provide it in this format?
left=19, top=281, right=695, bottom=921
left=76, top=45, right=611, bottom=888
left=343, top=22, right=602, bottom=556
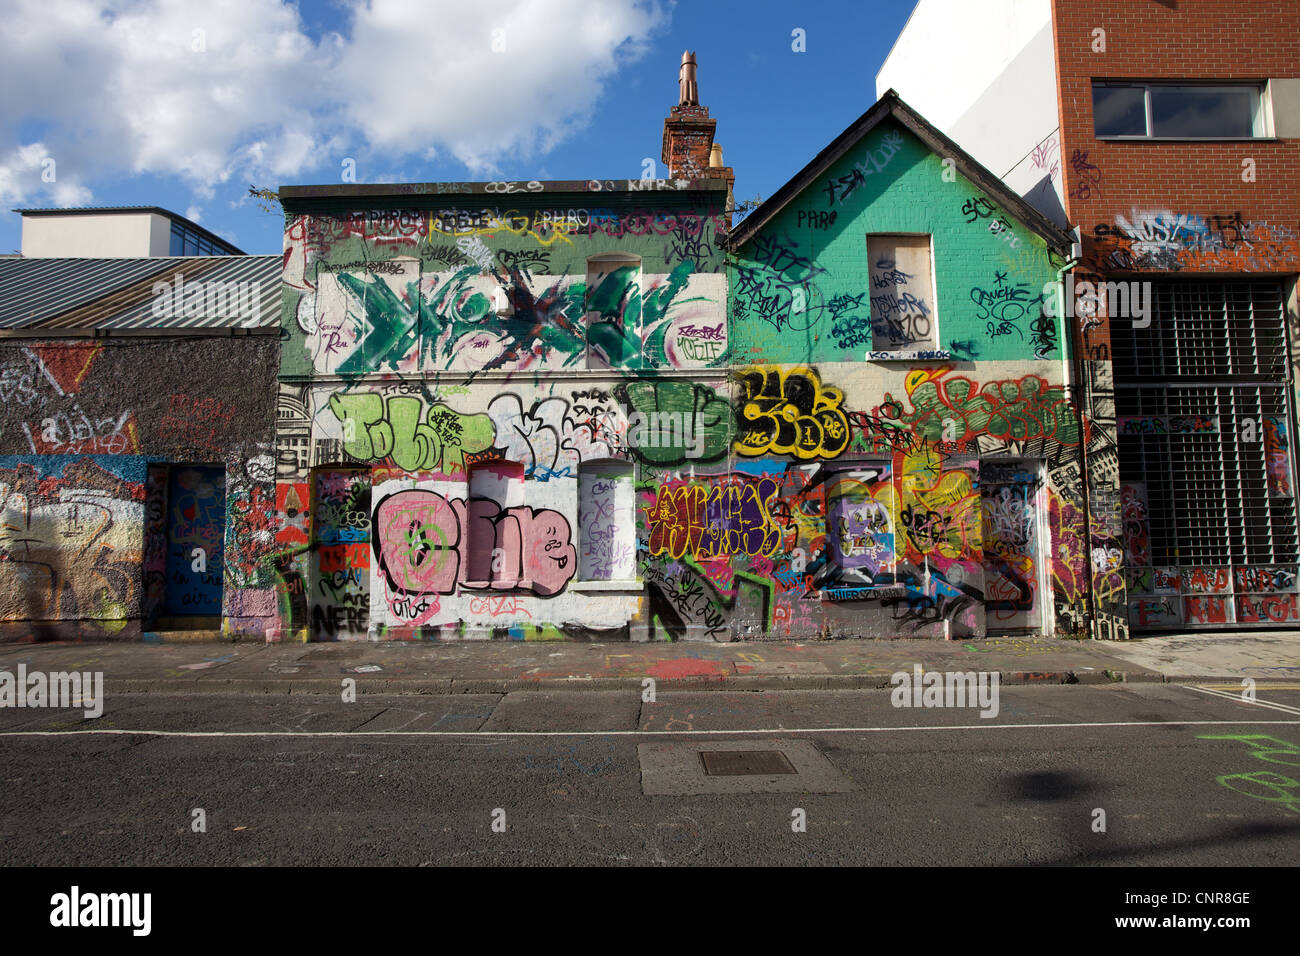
left=728, top=91, right=1088, bottom=637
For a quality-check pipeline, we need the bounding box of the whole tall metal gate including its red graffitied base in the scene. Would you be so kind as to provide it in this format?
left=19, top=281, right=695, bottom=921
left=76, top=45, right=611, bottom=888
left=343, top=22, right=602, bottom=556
left=1110, top=280, right=1300, bottom=630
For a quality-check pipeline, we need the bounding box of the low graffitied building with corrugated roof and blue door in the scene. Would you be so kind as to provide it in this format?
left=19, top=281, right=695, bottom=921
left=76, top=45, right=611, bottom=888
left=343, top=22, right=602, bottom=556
left=0, top=255, right=281, bottom=640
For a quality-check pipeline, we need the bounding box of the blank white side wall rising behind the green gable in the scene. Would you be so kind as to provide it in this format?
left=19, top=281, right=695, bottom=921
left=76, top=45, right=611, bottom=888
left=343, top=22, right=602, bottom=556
left=876, top=0, right=1065, bottom=225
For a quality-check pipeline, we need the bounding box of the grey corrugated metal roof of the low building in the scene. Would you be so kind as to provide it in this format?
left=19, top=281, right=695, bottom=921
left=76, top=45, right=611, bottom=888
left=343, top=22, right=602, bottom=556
left=0, top=256, right=283, bottom=334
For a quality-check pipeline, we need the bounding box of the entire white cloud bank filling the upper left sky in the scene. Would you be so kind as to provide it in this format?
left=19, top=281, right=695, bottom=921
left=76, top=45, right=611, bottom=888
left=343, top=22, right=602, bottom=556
left=0, top=0, right=664, bottom=204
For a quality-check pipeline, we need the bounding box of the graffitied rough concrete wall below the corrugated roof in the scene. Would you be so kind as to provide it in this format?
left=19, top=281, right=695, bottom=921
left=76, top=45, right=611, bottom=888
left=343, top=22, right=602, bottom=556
left=0, top=336, right=278, bottom=640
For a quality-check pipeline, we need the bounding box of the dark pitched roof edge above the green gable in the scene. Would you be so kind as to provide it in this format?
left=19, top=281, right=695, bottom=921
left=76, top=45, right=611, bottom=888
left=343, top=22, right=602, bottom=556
left=724, top=90, right=1074, bottom=255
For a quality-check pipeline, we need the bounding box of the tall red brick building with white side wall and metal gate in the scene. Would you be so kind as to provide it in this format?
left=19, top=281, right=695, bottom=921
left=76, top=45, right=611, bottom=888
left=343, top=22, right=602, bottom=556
left=878, top=0, right=1300, bottom=637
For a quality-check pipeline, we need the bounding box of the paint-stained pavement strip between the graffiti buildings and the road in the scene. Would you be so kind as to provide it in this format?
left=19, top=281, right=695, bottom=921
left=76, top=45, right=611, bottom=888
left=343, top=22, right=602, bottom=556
left=0, top=631, right=1300, bottom=695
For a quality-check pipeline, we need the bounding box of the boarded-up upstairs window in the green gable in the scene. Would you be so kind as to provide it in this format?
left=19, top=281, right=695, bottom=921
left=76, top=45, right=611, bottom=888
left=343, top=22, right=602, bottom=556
left=867, top=235, right=939, bottom=352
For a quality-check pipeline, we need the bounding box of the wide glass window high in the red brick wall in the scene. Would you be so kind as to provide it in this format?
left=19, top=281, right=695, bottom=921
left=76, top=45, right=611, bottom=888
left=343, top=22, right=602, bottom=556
left=1092, top=82, right=1268, bottom=139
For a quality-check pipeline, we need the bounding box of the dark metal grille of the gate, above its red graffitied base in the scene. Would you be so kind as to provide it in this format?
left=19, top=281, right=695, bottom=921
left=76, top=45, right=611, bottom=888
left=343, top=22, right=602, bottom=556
left=1112, top=281, right=1300, bottom=567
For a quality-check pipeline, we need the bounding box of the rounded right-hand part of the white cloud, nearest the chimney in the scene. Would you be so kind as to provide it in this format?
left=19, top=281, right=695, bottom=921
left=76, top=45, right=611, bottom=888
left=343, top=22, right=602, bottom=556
left=339, top=0, right=662, bottom=170
